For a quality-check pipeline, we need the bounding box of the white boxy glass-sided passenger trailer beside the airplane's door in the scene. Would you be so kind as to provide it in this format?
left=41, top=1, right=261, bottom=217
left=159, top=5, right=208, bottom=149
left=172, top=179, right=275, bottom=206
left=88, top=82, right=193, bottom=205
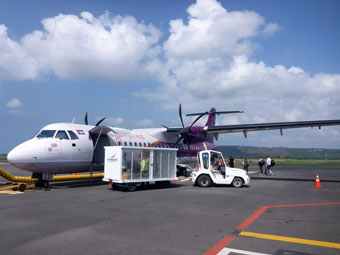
left=103, top=146, right=177, bottom=191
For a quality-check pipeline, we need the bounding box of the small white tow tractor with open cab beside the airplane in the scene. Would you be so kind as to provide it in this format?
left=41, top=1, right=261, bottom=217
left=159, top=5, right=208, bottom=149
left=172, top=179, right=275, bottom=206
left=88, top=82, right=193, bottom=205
left=191, top=150, right=250, bottom=188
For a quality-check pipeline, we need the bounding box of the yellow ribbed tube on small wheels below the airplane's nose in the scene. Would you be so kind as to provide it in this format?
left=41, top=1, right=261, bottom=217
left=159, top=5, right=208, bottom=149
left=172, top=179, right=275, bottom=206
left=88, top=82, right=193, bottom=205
left=0, top=168, right=104, bottom=191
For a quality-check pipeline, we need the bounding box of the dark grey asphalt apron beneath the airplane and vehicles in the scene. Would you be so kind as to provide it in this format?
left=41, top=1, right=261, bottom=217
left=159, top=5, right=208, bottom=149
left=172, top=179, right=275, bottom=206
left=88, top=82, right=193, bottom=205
left=0, top=163, right=340, bottom=255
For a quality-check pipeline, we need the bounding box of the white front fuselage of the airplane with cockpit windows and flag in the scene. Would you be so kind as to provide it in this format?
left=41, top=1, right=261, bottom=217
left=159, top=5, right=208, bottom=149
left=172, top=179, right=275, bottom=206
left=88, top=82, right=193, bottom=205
left=7, top=123, right=207, bottom=174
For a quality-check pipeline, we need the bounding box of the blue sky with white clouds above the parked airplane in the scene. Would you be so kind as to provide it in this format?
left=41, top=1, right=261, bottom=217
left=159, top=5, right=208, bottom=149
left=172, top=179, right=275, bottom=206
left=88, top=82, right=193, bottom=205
left=0, top=0, right=340, bottom=153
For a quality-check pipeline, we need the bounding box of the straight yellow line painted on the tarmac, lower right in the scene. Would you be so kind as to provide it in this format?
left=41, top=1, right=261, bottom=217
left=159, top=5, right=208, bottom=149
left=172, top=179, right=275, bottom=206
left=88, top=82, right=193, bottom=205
left=239, top=231, right=340, bottom=249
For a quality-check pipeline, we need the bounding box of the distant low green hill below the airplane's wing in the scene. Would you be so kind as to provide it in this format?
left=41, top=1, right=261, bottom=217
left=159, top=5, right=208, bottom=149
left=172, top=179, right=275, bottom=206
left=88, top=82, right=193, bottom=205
left=217, top=146, right=340, bottom=159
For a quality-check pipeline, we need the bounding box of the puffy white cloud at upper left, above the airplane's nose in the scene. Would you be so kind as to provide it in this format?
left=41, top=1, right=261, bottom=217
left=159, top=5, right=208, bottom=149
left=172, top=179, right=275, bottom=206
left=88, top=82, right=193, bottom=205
left=0, top=12, right=161, bottom=82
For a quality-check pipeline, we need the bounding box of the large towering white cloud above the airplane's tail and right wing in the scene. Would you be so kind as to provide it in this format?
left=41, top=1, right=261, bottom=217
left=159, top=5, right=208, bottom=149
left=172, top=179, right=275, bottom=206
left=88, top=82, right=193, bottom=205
left=135, top=0, right=340, bottom=123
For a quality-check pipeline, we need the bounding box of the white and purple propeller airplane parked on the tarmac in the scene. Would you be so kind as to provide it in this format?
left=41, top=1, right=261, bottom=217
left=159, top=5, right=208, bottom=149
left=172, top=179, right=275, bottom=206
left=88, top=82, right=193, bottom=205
left=7, top=104, right=340, bottom=185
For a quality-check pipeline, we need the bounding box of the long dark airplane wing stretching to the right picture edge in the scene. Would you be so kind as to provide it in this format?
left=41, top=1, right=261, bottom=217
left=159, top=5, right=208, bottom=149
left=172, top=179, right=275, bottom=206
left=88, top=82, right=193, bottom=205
left=204, top=120, right=340, bottom=136
